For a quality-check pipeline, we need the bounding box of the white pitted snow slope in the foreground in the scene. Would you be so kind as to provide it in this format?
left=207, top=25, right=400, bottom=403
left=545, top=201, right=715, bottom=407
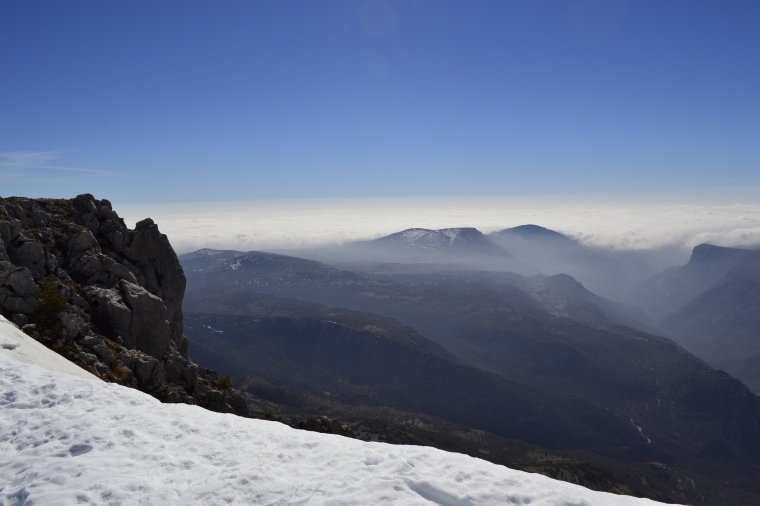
left=0, top=321, right=668, bottom=506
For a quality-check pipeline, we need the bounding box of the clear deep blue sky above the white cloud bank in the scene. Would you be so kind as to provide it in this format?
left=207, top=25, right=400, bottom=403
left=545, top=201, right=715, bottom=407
left=0, top=0, right=760, bottom=202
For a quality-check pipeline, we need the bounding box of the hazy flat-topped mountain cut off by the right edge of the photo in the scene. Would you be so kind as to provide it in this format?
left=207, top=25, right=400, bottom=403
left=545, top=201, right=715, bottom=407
left=629, top=244, right=760, bottom=393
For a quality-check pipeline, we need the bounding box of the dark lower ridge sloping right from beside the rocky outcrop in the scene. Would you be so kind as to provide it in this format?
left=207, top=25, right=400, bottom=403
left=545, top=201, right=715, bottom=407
left=186, top=292, right=658, bottom=458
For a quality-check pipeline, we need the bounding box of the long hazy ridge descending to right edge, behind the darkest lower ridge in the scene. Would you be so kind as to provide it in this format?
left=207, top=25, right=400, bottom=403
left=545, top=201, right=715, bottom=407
left=181, top=249, right=760, bottom=502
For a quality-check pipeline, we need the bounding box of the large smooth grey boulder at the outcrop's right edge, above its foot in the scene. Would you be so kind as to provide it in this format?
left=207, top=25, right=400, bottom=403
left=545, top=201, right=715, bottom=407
left=119, top=280, right=171, bottom=358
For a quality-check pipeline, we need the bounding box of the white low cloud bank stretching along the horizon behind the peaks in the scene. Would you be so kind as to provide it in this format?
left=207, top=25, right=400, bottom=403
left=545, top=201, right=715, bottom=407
left=115, top=196, right=760, bottom=253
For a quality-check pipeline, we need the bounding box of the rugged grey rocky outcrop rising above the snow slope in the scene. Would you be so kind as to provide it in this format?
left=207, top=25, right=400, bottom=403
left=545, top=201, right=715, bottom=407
left=0, top=194, right=249, bottom=416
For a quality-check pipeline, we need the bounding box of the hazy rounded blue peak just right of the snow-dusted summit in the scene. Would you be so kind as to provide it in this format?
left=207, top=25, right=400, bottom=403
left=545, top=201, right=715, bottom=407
left=488, top=225, right=651, bottom=300
